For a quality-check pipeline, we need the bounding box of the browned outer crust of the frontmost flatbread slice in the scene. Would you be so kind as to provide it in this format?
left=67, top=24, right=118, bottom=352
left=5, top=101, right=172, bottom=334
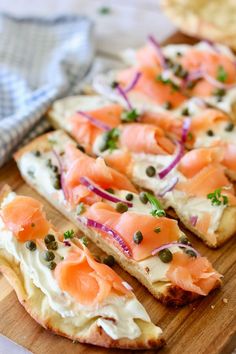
left=0, top=186, right=165, bottom=350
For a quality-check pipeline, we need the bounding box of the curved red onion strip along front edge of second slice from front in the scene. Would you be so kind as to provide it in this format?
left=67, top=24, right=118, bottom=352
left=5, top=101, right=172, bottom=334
left=78, top=217, right=132, bottom=257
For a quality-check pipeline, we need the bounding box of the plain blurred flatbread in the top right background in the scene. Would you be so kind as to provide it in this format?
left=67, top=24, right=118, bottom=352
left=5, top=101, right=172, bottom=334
left=162, top=0, right=236, bottom=50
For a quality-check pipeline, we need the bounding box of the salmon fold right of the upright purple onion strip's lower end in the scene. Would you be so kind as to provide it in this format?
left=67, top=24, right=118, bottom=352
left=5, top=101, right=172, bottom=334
left=178, top=147, right=224, bottom=178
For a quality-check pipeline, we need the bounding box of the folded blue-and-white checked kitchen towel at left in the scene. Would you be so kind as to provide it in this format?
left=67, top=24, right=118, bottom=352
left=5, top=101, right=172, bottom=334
left=0, top=14, right=94, bottom=166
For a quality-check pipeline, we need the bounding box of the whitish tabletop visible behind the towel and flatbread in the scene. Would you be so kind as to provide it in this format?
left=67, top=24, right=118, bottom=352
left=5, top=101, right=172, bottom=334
left=0, top=0, right=175, bottom=354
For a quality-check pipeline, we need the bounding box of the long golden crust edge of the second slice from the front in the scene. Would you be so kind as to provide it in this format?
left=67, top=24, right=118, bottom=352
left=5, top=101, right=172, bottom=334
left=14, top=133, right=221, bottom=306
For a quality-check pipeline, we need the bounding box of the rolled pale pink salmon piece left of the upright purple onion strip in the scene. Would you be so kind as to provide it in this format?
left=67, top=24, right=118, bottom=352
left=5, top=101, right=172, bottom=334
left=120, top=123, right=175, bottom=154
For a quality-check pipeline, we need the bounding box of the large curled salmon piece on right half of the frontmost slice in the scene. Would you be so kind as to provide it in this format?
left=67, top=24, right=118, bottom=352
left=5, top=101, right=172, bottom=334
left=54, top=247, right=132, bottom=306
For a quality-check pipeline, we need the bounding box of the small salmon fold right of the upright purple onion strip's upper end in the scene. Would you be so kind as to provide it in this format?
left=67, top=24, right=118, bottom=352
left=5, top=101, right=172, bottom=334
left=190, top=109, right=229, bottom=133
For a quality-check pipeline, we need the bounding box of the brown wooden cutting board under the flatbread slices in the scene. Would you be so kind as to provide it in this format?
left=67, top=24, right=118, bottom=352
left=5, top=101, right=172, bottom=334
left=0, top=33, right=236, bottom=354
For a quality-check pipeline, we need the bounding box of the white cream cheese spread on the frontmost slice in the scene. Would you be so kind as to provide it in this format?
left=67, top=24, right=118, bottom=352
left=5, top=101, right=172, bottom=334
left=0, top=195, right=155, bottom=339
